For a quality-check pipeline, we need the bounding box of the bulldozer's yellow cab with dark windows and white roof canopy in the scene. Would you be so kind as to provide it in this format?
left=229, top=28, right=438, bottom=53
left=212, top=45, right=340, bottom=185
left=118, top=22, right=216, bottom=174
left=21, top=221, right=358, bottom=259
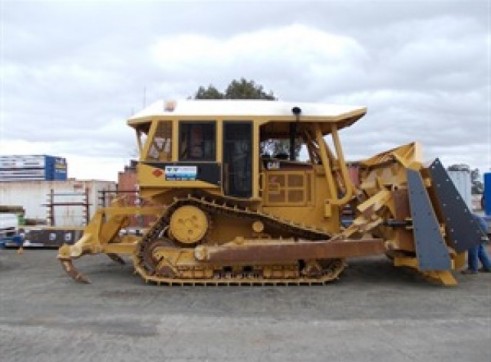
left=128, top=100, right=366, bottom=205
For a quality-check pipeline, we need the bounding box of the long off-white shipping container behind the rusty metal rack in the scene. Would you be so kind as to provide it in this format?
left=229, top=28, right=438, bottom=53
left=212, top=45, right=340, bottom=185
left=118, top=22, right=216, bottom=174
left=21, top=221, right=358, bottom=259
left=0, top=180, right=116, bottom=227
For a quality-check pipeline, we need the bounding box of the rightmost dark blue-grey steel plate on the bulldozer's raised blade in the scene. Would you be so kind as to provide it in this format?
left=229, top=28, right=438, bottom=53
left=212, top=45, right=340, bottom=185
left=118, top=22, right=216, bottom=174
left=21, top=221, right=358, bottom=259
left=428, top=158, right=482, bottom=253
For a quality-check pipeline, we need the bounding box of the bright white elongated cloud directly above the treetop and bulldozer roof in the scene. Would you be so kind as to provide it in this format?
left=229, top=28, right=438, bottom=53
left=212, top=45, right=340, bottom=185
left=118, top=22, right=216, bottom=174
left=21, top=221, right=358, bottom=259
left=149, top=24, right=365, bottom=99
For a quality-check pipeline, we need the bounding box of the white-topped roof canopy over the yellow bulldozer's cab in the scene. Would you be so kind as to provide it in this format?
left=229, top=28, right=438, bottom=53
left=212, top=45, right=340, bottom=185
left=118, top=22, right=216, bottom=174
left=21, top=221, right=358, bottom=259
left=128, top=99, right=367, bottom=134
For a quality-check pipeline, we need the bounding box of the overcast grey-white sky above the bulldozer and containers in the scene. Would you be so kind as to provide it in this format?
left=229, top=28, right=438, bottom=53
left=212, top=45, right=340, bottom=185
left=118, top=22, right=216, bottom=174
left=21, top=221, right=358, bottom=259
left=0, top=0, right=491, bottom=180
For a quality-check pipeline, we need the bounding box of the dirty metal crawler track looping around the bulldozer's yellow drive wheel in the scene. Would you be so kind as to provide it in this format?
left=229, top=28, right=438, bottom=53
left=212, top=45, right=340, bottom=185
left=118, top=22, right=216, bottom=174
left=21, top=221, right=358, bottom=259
left=134, top=195, right=345, bottom=286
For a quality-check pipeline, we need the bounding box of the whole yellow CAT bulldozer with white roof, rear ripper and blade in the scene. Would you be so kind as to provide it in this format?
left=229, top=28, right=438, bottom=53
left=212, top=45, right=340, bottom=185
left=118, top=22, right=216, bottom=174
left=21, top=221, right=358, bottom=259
left=58, top=100, right=480, bottom=285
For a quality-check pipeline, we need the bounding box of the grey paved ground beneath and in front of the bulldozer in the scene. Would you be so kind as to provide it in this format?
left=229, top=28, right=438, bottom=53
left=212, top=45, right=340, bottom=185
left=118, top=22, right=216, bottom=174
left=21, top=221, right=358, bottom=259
left=0, top=250, right=491, bottom=362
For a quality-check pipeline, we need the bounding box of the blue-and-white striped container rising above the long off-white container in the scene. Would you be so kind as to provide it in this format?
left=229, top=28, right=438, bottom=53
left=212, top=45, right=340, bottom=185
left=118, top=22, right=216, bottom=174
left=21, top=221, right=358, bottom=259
left=0, top=155, right=68, bottom=181
